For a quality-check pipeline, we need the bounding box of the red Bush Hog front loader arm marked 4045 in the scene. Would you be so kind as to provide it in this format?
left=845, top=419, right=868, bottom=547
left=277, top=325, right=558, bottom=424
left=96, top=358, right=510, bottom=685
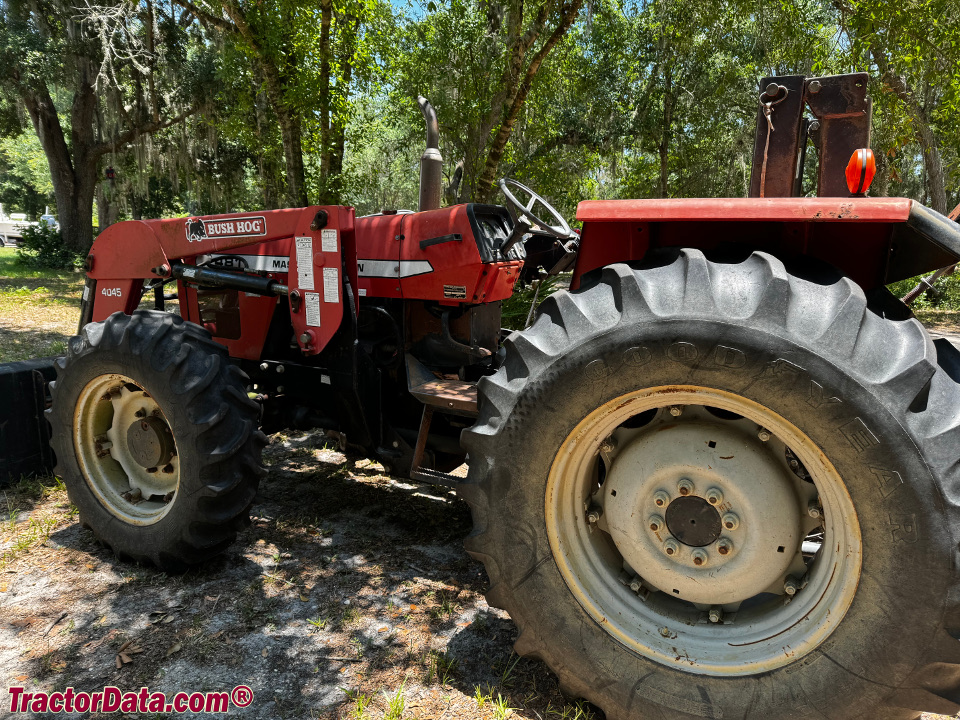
left=81, top=206, right=357, bottom=359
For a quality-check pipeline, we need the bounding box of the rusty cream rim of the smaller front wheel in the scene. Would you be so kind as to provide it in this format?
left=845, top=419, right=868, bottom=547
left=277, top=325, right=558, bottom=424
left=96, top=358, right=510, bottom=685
left=73, top=374, right=180, bottom=525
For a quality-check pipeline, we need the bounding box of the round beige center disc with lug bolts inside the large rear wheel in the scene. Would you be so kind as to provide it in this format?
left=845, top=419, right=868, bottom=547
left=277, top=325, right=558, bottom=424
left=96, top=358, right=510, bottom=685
left=603, top=421, right=803, bottom=605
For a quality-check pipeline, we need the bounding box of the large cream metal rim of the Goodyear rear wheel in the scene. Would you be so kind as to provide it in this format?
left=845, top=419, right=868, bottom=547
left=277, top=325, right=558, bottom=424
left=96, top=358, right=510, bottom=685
left=545, top=386, right=862, bottom=676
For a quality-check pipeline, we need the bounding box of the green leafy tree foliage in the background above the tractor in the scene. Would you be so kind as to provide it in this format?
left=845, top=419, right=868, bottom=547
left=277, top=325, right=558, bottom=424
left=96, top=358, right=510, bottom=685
left=0, top=0, right=960, bottom=233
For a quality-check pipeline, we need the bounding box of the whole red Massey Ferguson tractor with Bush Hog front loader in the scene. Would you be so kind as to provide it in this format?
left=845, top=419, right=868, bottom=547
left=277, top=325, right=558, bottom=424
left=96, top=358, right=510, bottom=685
left=1, top=74, right=960, bottom=720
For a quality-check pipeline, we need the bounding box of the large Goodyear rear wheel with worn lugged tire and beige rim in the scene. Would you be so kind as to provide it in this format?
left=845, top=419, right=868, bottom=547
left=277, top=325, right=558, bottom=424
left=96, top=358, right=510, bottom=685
left=459, top=250, right=960, bottom=720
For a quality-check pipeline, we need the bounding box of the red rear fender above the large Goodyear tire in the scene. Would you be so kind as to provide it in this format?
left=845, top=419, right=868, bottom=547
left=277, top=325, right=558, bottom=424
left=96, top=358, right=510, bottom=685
left=572, top=198, right=960, bottom=290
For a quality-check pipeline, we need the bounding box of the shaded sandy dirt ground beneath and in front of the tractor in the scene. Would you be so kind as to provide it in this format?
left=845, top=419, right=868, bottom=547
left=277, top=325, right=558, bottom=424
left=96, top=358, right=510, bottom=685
left=0, top=433, right=602, bottom=720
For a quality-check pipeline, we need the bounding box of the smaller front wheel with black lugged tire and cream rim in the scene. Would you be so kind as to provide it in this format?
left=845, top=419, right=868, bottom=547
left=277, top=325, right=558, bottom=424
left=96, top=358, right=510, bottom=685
left=47, top=310, right=266, bottom=571
